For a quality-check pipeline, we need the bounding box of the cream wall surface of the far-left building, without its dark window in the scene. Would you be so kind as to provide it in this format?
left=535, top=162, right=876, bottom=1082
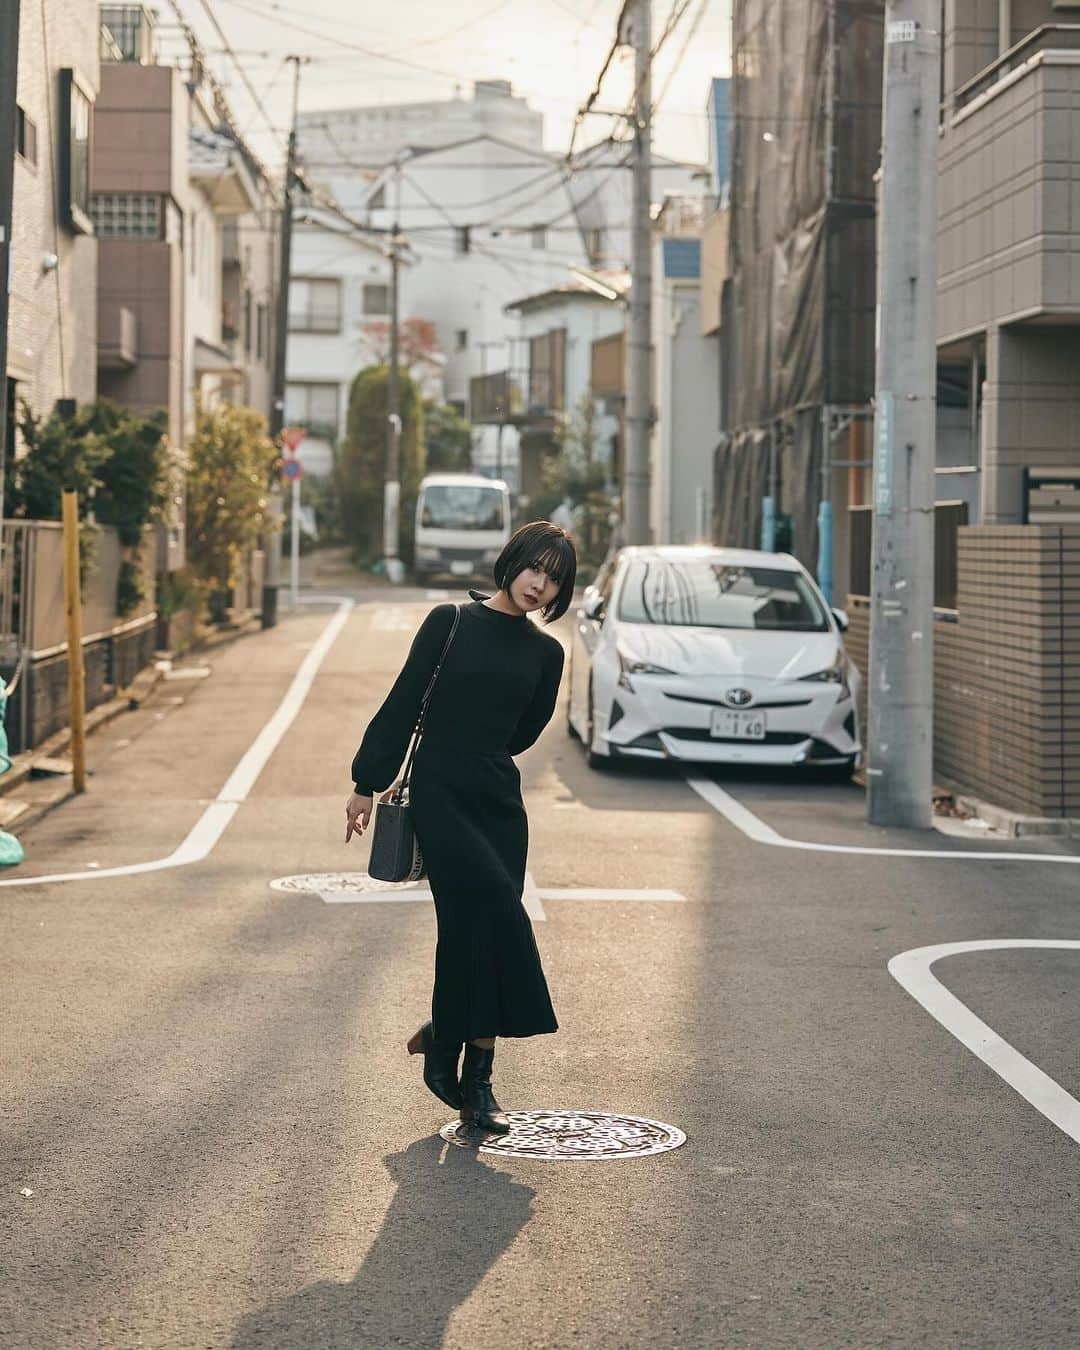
left=8, top=0, right=99, bottom=413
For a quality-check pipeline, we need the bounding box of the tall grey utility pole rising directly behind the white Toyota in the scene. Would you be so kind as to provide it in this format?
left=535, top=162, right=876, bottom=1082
left=622, top=0, right=652, bottom=544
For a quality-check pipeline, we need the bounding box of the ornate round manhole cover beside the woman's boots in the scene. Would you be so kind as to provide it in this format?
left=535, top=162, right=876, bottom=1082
left=439, top=1111, right=686, bottom=1162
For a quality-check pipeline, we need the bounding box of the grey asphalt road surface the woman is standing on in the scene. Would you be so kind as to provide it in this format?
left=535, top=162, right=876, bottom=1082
left=0, top=591, right=1080, bottom=1350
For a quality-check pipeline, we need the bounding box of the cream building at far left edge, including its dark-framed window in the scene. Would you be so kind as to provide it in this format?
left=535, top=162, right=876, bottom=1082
left=5, top=0, right=99, bottom=437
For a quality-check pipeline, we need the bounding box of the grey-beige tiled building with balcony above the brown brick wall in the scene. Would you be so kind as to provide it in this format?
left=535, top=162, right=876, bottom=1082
left=937, top=0, right=1080, bottom=525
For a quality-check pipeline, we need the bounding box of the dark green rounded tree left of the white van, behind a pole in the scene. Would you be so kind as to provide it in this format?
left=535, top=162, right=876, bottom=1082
left=338, top=366, right=424, bottom=563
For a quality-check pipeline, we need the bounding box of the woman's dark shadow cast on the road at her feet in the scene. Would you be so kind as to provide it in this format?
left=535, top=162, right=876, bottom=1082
left=231, top=1135, right=536, bottom=1350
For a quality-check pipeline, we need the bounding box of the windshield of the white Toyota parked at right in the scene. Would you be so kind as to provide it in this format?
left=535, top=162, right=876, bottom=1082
left=618, top=558, right=829, bottom=633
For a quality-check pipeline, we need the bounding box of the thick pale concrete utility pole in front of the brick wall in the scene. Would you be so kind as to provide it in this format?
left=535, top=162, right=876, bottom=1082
left=868, top=0, right=941, bottom=829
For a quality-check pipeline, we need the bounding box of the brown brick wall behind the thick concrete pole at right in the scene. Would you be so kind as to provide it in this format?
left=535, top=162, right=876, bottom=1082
left=848, top=525, right=1080, bottom=817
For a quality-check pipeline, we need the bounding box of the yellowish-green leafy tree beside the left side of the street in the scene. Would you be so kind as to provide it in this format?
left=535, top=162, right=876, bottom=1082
left=188, top=404, right=281, bottom=620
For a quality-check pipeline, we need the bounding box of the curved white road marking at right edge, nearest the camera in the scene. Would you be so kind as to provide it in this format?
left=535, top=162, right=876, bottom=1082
left=888, top=938, right=1080, bottom=1143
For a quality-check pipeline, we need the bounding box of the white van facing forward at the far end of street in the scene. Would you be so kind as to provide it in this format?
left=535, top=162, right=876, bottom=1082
left=413, top=474, right=510, bottom=578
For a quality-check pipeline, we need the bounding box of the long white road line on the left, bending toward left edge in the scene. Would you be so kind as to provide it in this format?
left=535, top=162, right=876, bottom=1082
left=0, top=595, right=354, bottom=887
